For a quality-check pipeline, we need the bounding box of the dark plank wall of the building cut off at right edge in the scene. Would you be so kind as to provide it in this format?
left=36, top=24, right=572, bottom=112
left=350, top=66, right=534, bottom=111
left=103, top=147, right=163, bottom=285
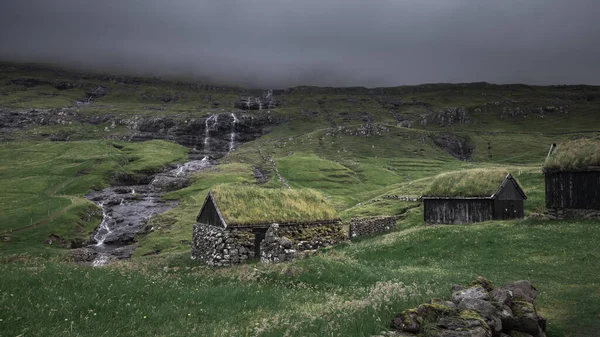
left=546, top=172, right=600, bottom=209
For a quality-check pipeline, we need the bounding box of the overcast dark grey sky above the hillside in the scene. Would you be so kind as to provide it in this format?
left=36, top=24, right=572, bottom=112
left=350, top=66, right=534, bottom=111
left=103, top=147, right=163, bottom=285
left=0, top=0, right=600, bottom=88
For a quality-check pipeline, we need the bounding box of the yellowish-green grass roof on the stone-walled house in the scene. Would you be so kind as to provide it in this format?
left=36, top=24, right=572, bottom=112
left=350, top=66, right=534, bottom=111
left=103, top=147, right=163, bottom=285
left=211, top=185, right=338, bottom=225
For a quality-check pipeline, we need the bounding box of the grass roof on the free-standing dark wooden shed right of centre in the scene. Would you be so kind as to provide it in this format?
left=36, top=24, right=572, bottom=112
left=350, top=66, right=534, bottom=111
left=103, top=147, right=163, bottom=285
left=423, top=169, right=508, bottom=197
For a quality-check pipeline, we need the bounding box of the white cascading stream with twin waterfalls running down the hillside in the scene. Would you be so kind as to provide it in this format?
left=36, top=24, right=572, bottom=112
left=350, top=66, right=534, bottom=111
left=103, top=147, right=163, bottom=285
left=81, top=113, right=240, bottom=267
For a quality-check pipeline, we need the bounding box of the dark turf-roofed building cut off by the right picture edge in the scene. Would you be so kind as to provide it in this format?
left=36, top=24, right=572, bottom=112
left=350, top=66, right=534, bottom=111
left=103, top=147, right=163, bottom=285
left=544, top=139, right=600, bottom=219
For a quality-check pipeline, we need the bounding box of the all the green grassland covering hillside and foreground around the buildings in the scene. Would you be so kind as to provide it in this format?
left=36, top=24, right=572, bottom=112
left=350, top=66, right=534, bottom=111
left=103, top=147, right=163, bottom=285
left=0, top=65, right=600, bottom=337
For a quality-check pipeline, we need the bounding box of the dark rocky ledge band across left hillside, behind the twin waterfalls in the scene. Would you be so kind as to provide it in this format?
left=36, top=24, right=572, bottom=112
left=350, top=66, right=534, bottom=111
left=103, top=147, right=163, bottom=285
left=0, top=109, right=280, bottom=158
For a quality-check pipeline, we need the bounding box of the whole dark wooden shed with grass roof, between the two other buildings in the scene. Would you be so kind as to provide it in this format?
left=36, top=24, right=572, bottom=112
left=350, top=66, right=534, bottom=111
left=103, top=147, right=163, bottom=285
left=422, top=169, right=527, bottom=224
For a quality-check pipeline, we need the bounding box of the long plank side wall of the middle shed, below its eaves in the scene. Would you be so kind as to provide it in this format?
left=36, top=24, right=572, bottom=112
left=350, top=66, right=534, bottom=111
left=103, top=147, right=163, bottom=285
left=423, top=199, right=494, bottom=224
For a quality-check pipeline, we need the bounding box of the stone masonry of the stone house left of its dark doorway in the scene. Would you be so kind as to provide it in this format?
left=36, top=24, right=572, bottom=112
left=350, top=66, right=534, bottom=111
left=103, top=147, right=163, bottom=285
left=192, top=224, right=255, bottom=267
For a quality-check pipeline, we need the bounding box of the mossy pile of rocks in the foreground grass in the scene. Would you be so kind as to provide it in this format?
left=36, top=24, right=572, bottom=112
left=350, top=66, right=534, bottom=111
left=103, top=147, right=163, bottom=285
left=392, top=277, right=546, bottom=337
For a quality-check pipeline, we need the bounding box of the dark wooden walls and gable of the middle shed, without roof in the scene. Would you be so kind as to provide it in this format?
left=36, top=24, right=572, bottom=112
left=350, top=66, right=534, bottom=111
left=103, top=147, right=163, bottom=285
left=422, top=174, right=527, bottom=224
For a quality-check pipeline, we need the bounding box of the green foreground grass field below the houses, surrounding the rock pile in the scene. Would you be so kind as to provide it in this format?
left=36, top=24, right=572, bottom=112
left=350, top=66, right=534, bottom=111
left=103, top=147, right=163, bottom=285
left=0, top=214, right=600, bottom=337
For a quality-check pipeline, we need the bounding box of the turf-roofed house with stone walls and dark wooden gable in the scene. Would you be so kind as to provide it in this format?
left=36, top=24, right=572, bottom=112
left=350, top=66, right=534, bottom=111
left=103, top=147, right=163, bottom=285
left=192, top=185, right=347, bottom=266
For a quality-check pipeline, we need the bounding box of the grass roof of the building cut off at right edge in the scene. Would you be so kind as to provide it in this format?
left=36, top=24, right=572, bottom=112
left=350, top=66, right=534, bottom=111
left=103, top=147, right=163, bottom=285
left=544, top=138, right=600, bottom=172
